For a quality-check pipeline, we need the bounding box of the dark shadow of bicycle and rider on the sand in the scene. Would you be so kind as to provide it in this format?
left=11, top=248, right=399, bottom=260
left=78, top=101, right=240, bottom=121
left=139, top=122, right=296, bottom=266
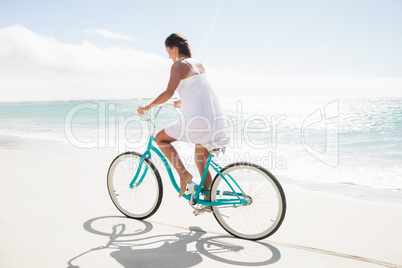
left=68, top=216, right=281, bottom=268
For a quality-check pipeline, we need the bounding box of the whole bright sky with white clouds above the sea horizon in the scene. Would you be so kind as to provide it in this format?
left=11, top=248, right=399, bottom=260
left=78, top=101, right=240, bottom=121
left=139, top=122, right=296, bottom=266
left=0, top=0, right=402, bottom=102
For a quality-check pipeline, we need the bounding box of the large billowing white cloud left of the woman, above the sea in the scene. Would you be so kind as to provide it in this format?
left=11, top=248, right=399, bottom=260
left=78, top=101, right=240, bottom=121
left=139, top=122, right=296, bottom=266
left=0, top=25, right=171, bottom=101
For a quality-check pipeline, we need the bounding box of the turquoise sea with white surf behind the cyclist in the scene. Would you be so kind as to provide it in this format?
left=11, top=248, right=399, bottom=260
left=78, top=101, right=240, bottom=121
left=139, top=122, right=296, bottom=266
left=0, top=97, right=402, bottom=191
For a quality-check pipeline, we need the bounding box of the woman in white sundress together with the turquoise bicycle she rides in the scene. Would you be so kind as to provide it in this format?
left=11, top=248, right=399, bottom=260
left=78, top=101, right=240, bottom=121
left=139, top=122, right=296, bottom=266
left=107, top=34, right=286, bottom=240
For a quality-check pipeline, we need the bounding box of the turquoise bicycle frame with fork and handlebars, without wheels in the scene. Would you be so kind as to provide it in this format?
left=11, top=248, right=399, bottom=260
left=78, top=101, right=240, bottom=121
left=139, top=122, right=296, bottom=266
left=130, top=106, right=247, bottom=207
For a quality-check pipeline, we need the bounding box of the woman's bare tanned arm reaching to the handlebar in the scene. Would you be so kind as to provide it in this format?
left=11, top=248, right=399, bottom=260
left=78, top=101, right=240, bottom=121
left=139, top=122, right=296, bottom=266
left=137, top=61, right=182, bottom=115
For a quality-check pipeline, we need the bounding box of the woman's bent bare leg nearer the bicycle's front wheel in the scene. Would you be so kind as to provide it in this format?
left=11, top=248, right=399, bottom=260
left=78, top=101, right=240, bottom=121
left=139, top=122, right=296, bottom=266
left=155, top=130, right=193, bottom=197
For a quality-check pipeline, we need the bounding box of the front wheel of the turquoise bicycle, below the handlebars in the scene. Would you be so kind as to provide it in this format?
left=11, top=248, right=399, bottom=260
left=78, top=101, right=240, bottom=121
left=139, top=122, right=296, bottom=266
left=107, top=152, right=163, bottom=220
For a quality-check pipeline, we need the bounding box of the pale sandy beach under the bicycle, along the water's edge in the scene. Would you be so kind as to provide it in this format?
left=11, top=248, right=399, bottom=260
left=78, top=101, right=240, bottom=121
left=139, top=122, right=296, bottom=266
left=0, top=139, right=402, bottom=268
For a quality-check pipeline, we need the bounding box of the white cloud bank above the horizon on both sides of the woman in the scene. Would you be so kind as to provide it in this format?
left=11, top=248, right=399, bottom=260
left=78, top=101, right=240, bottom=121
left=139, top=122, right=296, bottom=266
left=0, top=25, right=402, bottom=102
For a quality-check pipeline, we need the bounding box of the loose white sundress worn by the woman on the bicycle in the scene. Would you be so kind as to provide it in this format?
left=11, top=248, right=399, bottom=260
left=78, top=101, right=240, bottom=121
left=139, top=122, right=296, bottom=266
left=164, top=58, right=229, bottom=151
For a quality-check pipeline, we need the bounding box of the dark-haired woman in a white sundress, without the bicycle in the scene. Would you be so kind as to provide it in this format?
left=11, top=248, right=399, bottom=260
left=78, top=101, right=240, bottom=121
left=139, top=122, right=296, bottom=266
left=138, top=33, right=228, bottom=197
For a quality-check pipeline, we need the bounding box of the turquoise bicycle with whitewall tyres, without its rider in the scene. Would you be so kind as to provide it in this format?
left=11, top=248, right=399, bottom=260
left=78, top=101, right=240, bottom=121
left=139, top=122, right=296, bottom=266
left=107, top=103, right=286, bottom=240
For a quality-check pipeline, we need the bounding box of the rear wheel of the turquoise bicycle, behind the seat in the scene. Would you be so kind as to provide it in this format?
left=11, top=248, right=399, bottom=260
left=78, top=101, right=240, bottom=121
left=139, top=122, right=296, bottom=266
left=211, top=162, right=286, bottom=240
